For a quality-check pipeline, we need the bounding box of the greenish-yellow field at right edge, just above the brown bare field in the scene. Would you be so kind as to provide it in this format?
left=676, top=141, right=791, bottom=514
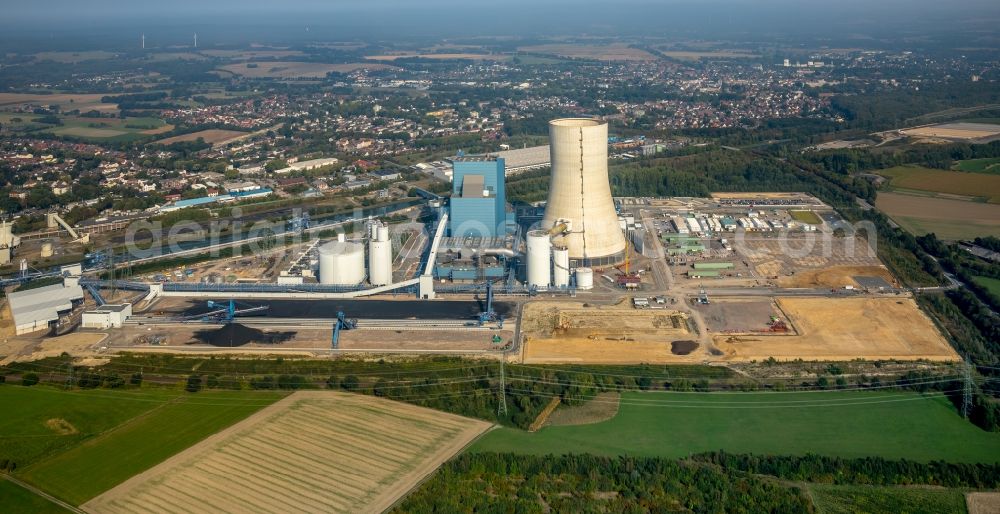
left=873, top=166, right=1000, bottom=203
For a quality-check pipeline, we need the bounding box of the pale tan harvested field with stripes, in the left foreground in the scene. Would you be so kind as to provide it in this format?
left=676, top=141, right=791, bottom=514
left=83, top=391, right=490, bottom=513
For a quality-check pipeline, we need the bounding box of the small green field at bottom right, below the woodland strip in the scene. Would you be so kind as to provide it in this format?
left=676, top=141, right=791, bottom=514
left=808, top=484, right=966, bottom=514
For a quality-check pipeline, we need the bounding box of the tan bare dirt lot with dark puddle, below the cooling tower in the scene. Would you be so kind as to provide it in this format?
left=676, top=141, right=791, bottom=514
left=521, top=302, right=704, bottom=364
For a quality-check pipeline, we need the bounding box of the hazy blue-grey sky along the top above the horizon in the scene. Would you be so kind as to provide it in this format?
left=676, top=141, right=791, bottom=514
left=0, top=0, right=1000, bottom=42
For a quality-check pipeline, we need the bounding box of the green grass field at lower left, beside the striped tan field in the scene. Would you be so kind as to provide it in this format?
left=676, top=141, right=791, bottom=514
left=0, top=386, right=284, bottom=505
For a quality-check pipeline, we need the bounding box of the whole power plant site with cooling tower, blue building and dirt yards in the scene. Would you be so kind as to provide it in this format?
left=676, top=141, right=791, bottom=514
left=3, top=118, right=955, bottom=364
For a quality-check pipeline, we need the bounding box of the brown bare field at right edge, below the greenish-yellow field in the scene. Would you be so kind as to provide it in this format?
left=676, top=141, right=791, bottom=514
left=875, top=192, right=1000, bottom=240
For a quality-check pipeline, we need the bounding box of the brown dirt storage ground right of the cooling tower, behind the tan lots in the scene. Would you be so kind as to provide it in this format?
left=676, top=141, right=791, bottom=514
left=734, top=233, right=880, bottom=280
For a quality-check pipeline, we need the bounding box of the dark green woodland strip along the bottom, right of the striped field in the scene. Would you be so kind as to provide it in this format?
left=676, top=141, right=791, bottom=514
left=395, top=452, right=1000, bottom=513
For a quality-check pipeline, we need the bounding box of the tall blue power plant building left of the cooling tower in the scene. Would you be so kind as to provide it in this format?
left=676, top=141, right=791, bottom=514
left=448, top=156, right=507, bottom=238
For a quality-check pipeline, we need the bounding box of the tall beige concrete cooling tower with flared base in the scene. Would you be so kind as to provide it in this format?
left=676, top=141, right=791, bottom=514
left=542, top=118, right=625, bottom=267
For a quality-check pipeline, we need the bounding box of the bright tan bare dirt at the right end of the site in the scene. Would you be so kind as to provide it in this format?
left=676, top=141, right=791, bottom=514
left=714, top=297, right=959, bottom=362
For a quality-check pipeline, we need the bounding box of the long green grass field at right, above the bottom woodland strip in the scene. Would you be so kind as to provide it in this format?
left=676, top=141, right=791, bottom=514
left=470, top=391, right=1000, bottom=462
